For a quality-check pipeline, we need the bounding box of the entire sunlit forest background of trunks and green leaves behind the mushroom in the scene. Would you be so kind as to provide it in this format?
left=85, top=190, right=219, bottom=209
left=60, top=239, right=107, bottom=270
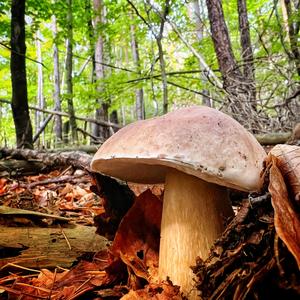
left=0, top=0, right=300, bottom=148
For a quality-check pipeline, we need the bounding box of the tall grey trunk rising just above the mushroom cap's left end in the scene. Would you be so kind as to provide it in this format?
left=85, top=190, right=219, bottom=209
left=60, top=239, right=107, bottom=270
left=92, top=0, right=110, bottom=140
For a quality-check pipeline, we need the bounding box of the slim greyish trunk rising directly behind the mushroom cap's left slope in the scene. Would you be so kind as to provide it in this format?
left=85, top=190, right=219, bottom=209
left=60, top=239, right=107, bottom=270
left=130, top=12, right=145, bottom=120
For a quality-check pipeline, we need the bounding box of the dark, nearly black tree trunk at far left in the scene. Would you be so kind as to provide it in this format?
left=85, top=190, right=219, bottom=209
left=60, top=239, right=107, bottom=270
left=10, top=0, right=33, bottom=148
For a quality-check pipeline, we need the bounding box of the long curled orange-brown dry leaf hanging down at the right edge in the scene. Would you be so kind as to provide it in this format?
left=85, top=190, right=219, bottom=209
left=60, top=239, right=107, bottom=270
left=267, top=154, right=300, bottom=268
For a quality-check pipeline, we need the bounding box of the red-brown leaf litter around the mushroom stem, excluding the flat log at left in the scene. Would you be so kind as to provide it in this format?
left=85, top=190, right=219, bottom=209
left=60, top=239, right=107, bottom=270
left=0, top=146, right=300, bottom=300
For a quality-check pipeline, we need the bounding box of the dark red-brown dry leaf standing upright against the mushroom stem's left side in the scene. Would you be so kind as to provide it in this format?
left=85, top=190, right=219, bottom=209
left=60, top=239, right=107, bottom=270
left=112, top=190, right=162, bottom=280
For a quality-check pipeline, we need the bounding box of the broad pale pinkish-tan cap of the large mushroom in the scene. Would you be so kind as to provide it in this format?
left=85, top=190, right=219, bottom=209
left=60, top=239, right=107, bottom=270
left=91, top=106, right=266, bottom=191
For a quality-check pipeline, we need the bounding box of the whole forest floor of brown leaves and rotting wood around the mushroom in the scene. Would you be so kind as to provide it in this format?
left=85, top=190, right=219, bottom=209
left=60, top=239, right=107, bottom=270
left=0, top=145, right=300, bottom=300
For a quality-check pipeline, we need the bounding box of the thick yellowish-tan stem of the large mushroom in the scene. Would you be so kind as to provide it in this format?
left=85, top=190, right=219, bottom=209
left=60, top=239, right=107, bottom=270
left=159, top=170, right=233, bottom=299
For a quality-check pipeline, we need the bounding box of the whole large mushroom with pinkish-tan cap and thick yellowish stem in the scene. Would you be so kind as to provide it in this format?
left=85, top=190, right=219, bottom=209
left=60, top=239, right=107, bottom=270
left=91, top=106, right=266, bottom=299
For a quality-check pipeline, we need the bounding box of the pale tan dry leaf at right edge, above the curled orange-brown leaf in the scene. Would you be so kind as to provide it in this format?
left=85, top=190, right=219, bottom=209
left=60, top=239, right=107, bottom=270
left=271, top=145, right=300, bottom=206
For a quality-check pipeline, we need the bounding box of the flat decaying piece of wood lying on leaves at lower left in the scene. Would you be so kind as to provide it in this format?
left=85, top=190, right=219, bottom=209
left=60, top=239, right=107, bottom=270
left=0, top=225, right=107, bottom=270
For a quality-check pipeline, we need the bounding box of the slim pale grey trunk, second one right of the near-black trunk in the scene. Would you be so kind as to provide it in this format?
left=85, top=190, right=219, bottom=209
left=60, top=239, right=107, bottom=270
left=52, top=15, right=62, bottom=143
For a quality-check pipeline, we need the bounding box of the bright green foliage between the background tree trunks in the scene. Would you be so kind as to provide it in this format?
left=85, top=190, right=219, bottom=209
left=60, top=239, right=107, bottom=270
left=0, top=0, right=299, bottom=145
